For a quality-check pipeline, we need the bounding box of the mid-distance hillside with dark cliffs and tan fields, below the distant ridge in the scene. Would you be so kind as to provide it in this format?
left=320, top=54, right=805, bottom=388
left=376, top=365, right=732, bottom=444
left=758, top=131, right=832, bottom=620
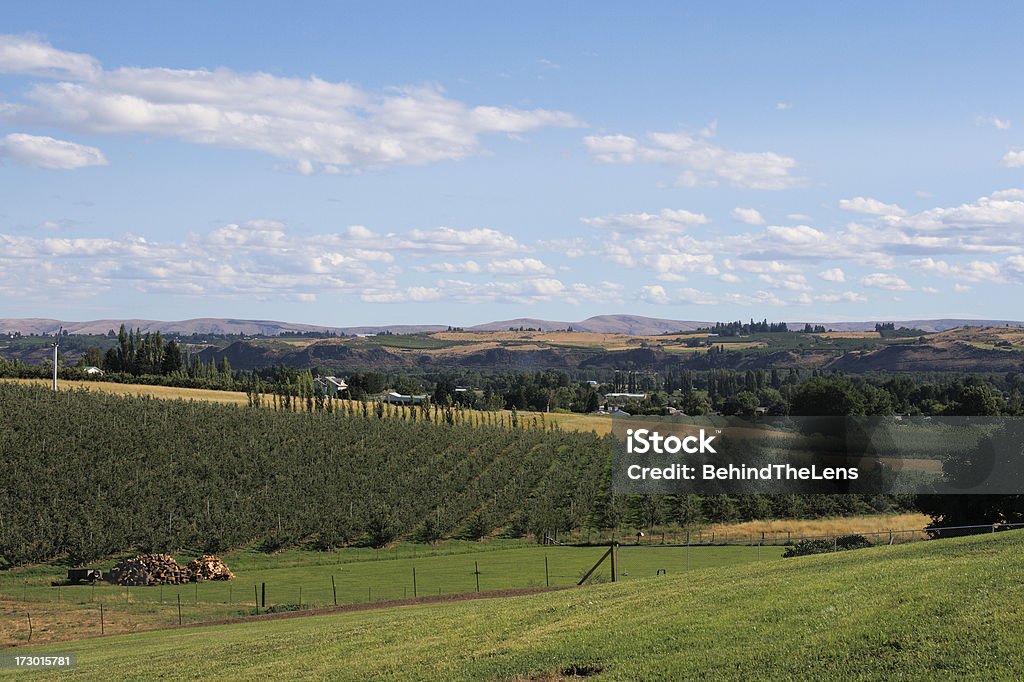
left=190, top=327, right=1024, bottom=373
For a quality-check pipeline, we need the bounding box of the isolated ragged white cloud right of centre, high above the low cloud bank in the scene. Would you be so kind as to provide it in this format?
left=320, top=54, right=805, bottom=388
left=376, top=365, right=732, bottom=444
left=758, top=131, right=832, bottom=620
left=584, top=124, right=806, bottom=189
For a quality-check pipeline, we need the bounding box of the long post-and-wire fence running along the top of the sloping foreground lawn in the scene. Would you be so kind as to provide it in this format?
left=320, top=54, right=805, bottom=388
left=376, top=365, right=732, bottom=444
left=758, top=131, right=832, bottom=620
left=0, top=523, right=1024, bottom=646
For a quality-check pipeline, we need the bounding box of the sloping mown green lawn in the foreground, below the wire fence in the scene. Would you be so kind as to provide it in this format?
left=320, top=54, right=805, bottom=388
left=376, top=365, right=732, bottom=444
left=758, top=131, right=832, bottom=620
left=9, top=531, right=1024, bottom=680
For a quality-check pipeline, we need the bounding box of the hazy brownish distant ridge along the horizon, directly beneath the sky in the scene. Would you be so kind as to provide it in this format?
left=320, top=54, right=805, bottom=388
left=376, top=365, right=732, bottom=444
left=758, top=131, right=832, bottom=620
left=0, top=314, right=1024, bottom=336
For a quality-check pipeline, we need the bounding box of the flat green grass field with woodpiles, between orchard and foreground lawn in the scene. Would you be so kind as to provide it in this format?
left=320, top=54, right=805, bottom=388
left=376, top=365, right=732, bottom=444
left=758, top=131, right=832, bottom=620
left=0, top=540, right=782, bottom=645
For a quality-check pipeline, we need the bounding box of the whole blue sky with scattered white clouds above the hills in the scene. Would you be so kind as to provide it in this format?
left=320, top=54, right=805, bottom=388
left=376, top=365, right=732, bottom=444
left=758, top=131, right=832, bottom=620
left=0, top=2, right=1024, bottom=325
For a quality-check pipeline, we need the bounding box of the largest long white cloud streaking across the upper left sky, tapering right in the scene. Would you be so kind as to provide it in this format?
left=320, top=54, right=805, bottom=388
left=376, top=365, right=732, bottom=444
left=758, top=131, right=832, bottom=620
left=0, top=36, right=580, bottom=174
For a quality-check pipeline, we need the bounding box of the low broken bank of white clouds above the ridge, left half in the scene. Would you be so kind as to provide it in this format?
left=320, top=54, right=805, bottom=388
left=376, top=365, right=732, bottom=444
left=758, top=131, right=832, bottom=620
left=0, top=220, right=536, bottom=302
